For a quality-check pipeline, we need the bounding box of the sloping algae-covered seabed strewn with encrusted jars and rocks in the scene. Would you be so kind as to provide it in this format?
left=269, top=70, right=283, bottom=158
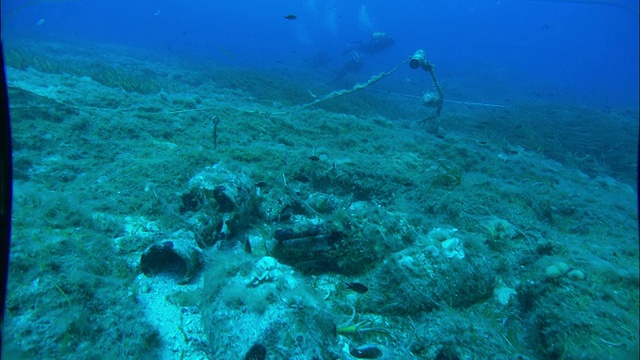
left=3, top=41, right=639, bottom=360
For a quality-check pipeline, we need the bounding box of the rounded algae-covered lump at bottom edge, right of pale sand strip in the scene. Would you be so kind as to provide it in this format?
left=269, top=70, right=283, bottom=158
left=200, top=252, right=340, bottom=360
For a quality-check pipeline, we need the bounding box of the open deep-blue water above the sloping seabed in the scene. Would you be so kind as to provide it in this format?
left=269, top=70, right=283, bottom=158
left=2, top=0, right=639, bottom=108
